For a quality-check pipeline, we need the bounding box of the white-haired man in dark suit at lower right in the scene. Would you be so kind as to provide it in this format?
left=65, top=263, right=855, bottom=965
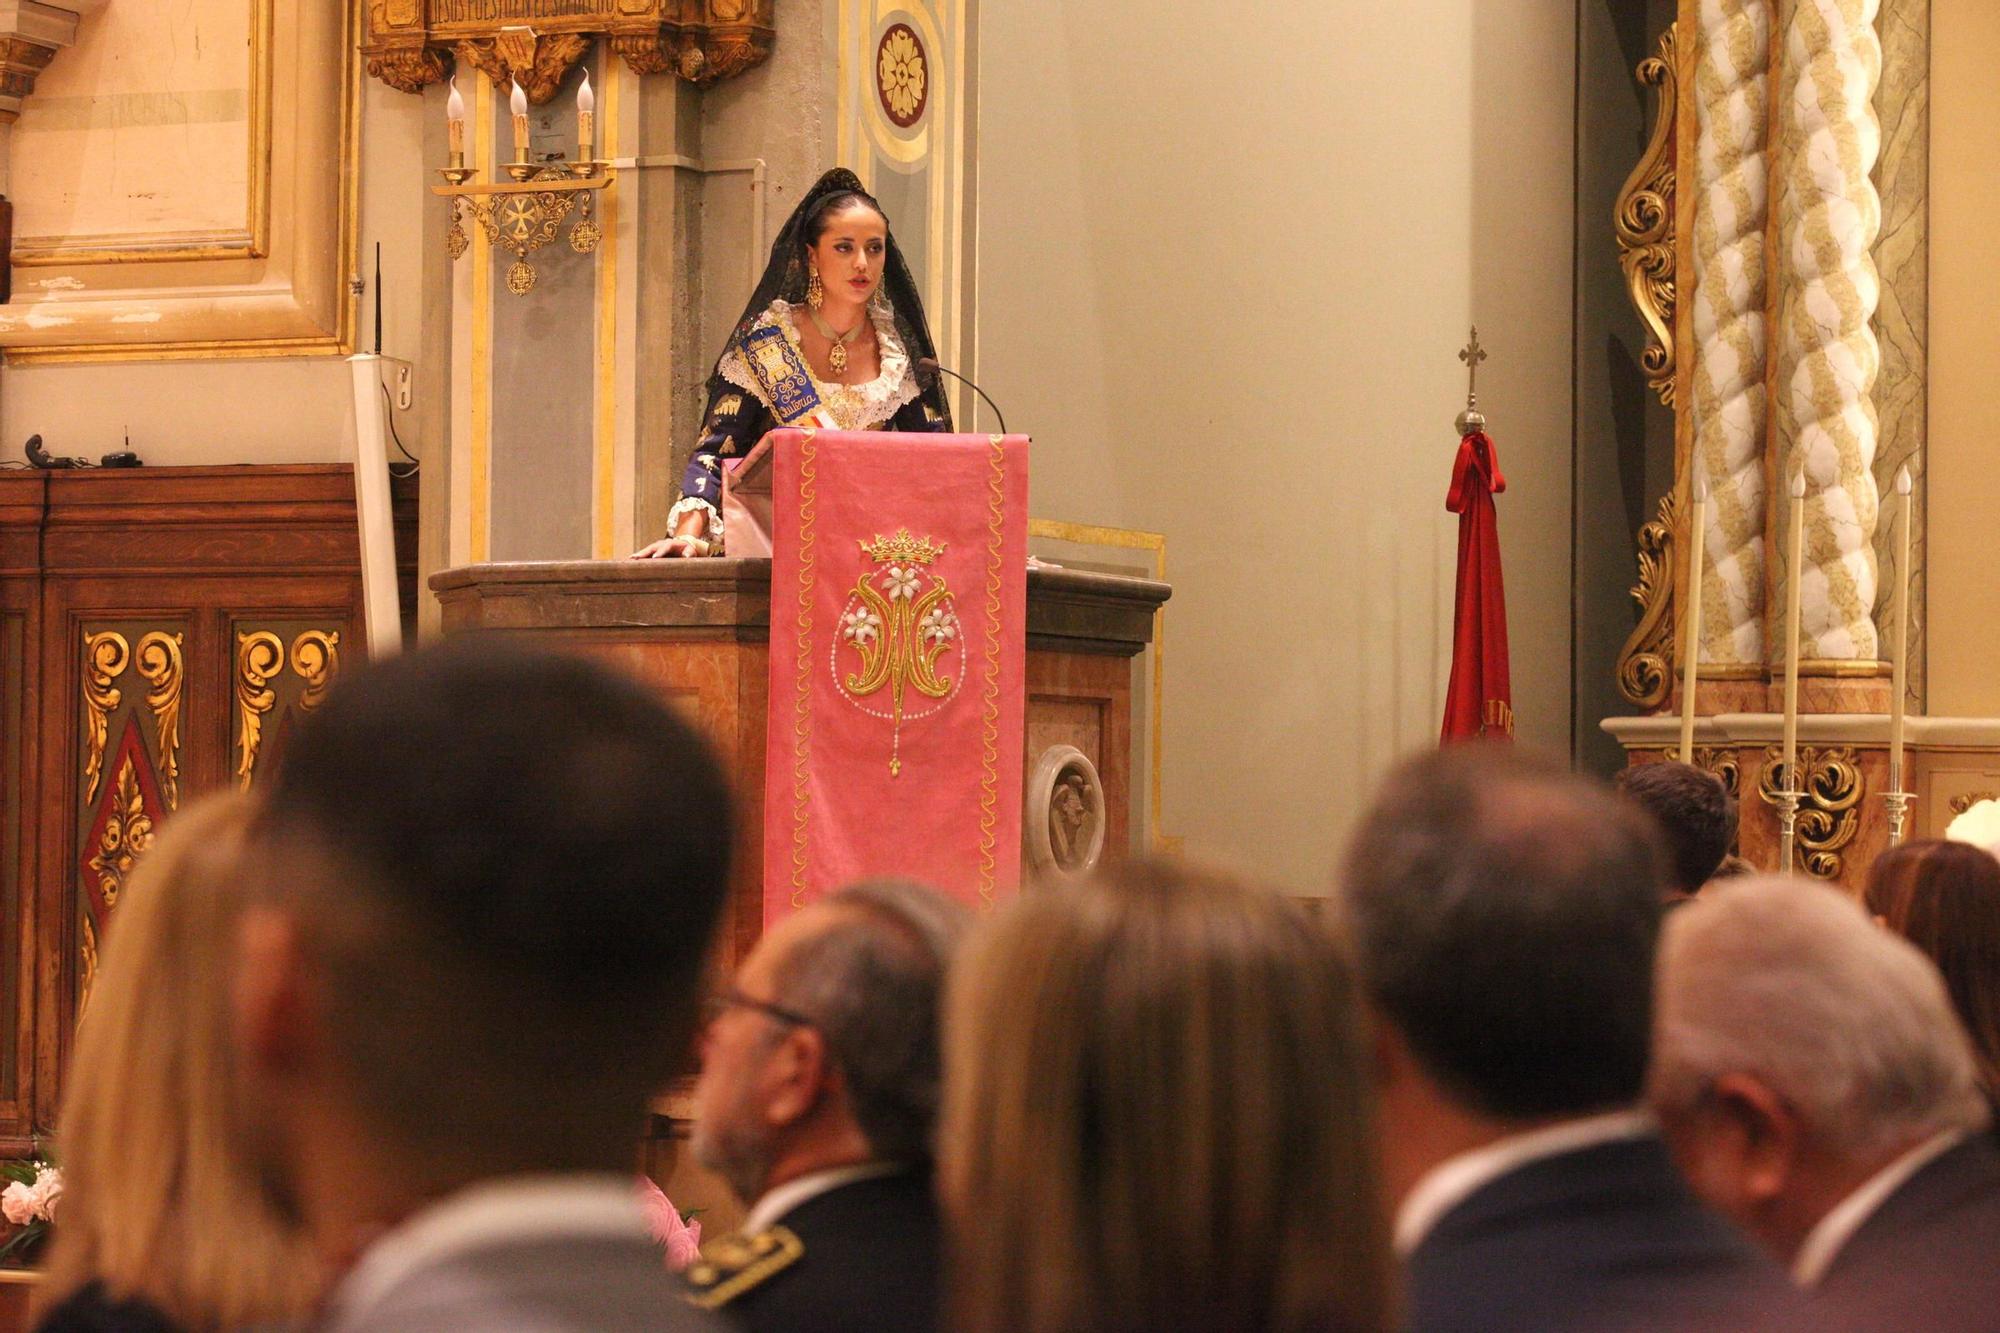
left=1652, top=879, right=2000, bottom=1333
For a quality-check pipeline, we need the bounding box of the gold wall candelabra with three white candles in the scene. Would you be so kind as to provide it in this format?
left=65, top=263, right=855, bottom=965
left=430, top=74, right=614, bottom=296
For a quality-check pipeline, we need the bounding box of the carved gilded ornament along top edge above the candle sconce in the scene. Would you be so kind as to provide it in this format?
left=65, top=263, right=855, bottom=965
left=360, top=0, right=776, bottom=96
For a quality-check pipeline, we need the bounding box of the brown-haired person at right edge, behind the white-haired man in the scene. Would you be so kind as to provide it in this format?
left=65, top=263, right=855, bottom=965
left=1864, top=839, right=2000, bottom=1101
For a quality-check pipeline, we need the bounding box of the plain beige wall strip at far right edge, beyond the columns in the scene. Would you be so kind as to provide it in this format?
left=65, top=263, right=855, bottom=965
left=1922, top=0, right=2000, bottom=717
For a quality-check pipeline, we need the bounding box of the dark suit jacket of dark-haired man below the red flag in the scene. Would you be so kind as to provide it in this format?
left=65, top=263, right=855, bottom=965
left=1404, top=1137, right=1792, bottom=1333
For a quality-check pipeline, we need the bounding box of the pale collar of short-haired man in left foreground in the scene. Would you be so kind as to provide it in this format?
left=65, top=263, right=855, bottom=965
left=330, top=1173, right=646, bottom=1317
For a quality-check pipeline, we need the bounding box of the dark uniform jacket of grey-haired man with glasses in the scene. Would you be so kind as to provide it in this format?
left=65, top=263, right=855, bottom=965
left=720, top=1171, right=942, bottom=1333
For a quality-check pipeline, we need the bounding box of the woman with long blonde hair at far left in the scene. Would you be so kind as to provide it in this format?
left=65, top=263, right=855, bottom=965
left=38, top=797, right=318, bottom=1333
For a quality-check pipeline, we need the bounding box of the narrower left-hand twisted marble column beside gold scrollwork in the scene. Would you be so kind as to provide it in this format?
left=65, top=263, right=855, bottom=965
left=1692, top=0, right=1772, bottom=664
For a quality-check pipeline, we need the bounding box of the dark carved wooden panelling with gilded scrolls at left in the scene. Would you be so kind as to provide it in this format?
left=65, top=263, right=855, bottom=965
left=0, top=466, right=414, bottom=1157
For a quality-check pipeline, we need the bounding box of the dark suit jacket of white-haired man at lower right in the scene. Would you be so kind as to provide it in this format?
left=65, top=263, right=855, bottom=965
left=1812, top=1135, right=2000, bottom=1333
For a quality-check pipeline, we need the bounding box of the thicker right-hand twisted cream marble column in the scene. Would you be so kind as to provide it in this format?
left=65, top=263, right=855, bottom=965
left=1776, top=0, right=1882, bottom=660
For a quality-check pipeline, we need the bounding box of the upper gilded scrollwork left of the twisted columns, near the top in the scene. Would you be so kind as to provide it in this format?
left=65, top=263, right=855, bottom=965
left=1612, top=26, right=1678, bottom=406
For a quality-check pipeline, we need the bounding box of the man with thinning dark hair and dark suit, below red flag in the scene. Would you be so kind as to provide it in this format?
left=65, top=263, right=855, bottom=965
left=1334, top=747, right=1788, bottom=1333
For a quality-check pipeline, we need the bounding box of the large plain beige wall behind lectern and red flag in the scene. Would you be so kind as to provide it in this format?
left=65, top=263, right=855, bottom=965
left=976, top=0, right=1574, bottom=891
